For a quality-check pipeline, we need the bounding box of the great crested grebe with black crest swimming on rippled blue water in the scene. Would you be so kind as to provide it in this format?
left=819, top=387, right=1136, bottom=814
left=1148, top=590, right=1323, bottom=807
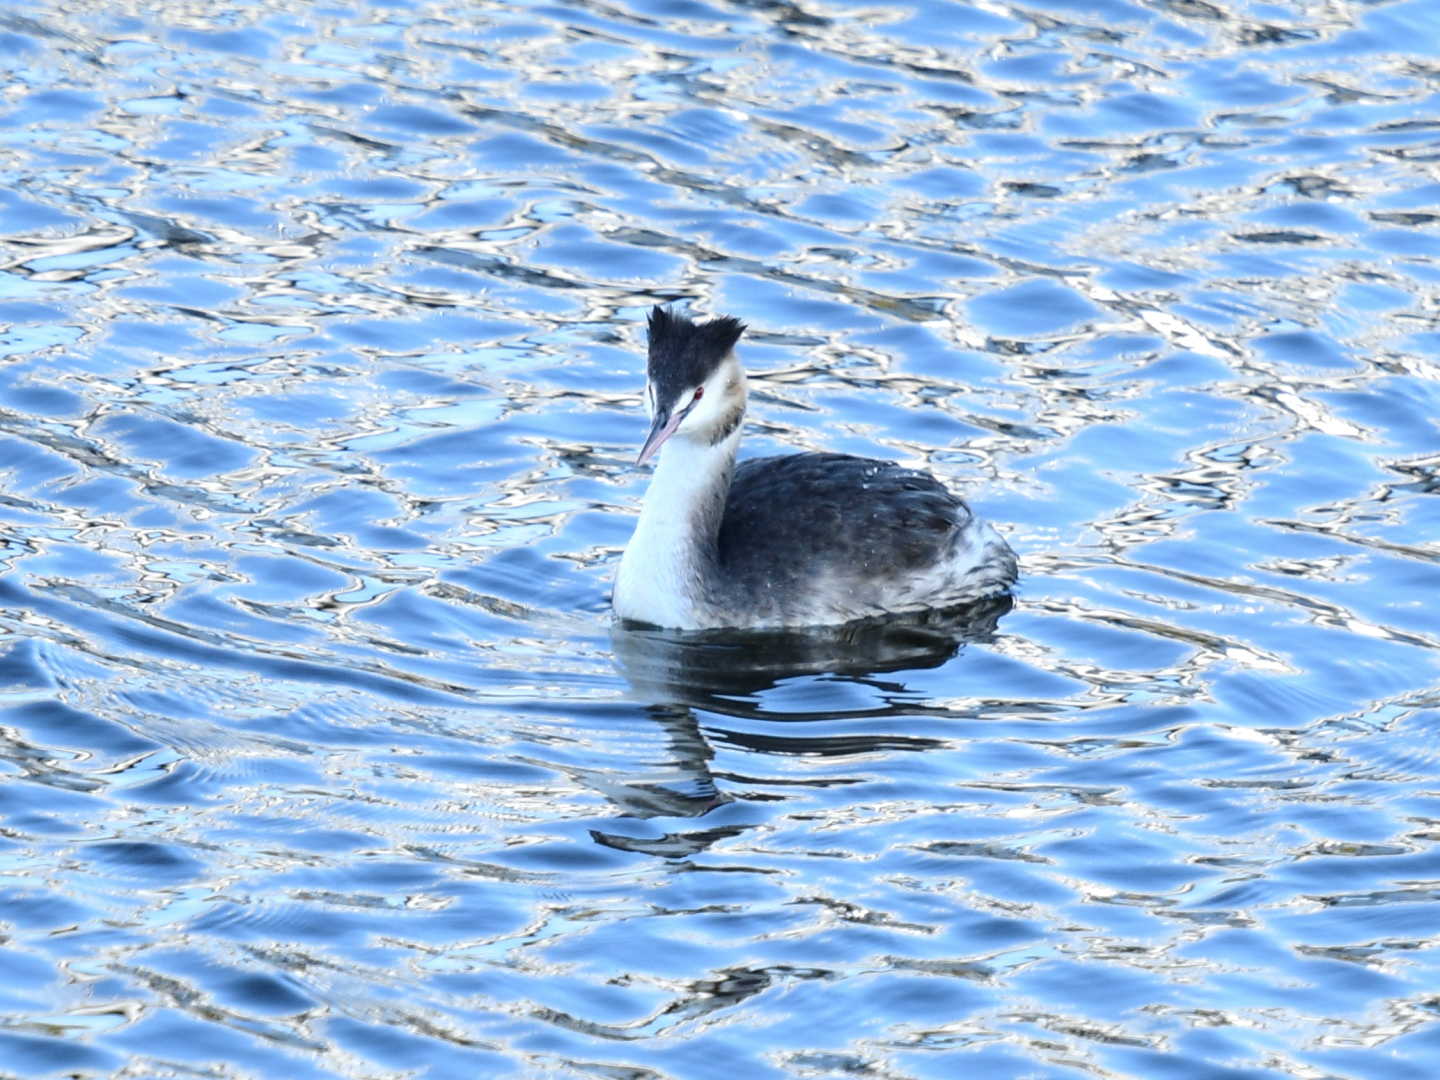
left=612, top=305, right=1015, bottom=629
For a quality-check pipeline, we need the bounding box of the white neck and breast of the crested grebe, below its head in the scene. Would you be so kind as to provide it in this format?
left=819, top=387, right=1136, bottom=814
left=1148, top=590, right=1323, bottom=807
left=613, top=426, right=740, bottom=629
